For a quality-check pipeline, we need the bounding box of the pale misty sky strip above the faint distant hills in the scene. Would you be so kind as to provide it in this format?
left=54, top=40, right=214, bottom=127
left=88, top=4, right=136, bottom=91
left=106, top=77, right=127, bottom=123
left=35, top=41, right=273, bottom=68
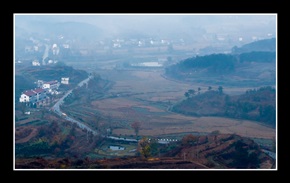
left=15, top=14, right=277, bottom=40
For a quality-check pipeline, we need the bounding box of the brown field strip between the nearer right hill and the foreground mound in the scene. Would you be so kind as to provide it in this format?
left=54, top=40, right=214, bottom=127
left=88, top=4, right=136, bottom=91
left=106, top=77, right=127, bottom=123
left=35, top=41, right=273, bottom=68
left=113, top=116, right=276, bottom=139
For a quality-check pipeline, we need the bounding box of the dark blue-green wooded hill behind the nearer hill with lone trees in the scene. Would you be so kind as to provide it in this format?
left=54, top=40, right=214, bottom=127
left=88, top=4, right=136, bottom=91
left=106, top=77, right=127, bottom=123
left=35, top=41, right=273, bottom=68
left=165, top=49, right=276, bottom=87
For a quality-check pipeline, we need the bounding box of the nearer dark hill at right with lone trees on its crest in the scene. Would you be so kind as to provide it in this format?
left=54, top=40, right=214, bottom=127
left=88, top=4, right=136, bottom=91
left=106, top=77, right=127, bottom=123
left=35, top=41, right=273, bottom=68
left=172, top=87, right=276, bottom=127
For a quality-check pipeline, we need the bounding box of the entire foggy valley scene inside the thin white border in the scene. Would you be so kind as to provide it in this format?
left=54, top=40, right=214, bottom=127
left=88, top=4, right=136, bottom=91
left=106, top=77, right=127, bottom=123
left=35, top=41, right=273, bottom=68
left=13, top=14, right=277, bottom=170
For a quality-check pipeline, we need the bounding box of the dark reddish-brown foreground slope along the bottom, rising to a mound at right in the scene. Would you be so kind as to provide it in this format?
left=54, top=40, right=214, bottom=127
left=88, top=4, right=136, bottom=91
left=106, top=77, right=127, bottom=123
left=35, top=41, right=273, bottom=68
left=16, top=133, right=275, bottom=169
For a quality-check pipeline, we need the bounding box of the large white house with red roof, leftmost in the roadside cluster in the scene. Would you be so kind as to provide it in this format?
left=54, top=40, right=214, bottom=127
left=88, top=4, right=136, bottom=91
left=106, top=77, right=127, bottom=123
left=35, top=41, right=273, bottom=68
left=19, top=88, right=47, bottom=103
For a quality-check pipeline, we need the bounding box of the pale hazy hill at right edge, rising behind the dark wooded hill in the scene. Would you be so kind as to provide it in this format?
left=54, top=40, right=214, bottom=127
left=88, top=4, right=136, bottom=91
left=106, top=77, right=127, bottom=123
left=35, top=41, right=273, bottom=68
left=232, top=38, right=276, bottom=54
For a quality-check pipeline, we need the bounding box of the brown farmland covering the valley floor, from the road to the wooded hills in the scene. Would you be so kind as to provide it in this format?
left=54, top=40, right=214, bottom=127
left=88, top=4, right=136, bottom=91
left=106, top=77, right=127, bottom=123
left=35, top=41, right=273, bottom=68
left=76, top=69, right=276, bottom=139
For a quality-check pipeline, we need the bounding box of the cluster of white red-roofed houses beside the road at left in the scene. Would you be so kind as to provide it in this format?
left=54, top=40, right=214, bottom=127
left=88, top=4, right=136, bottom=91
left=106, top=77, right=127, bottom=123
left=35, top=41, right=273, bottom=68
left=19, top=77, right=69, bottom=107
